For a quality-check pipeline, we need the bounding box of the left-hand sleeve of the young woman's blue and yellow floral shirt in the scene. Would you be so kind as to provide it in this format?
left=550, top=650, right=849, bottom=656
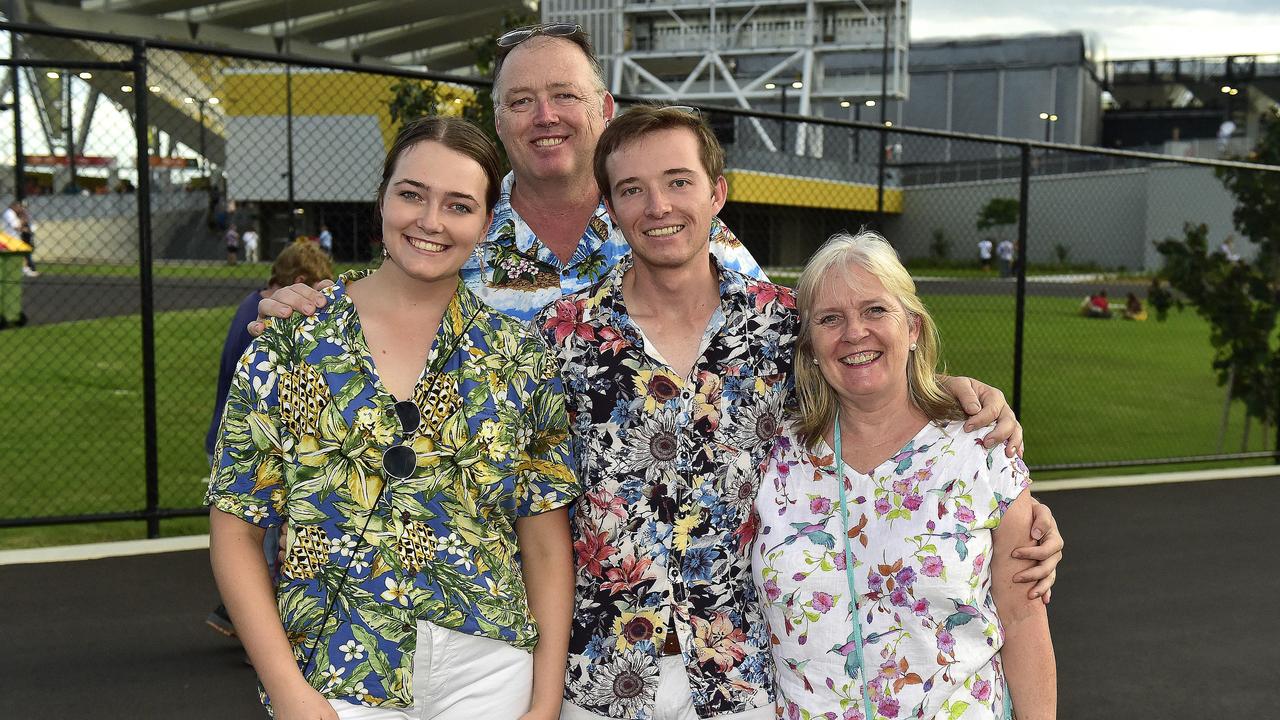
left=205, top=320, right=287, bottom=528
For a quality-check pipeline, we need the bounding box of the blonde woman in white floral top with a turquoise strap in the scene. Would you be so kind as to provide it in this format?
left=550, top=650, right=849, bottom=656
left=753, top=233, right=1057, bottom=720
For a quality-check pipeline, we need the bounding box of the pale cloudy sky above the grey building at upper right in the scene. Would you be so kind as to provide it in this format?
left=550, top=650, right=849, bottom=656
left=911, top=0, right=1280, bottom=59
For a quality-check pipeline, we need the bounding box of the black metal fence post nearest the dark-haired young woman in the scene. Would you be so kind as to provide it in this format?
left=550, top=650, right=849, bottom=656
left=133, top=40, right=160, bottom=538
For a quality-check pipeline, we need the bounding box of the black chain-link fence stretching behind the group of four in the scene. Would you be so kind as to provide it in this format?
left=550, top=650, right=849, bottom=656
left=0, top=26, right=1275, bottom=536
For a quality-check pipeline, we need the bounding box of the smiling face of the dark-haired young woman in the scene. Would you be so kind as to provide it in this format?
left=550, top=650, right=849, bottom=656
left=381, top=141, right=490, bottom=282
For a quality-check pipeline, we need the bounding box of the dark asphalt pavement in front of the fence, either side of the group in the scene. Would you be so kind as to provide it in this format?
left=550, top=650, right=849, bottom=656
left=0, top=477, right=1280, bottom=720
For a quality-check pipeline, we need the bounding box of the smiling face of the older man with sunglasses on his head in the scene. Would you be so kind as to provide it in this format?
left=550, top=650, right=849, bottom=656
left=494, top=36, right=613, bottom=181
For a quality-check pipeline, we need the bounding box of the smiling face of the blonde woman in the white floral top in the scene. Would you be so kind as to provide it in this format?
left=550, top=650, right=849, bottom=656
left=809, top=265, right=920, bottom=405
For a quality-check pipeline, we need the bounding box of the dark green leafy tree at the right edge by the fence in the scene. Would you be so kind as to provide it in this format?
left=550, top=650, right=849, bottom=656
left=1148, top=113, right=1280, bottom=440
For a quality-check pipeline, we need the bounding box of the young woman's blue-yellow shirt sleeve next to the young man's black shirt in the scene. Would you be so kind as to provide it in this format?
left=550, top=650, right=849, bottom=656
left=516, top=338, right=582, bottom=518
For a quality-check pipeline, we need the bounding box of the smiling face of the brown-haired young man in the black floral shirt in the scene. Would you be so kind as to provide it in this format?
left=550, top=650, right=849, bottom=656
left=604, top=127, right=728, bottom=268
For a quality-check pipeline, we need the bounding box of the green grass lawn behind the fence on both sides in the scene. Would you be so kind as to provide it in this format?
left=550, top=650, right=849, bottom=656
left=0, top=288, right=1263, bottom=547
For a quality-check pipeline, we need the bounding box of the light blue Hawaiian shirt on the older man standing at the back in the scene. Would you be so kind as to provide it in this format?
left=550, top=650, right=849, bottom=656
left=462, top=173, right=768, bottom=323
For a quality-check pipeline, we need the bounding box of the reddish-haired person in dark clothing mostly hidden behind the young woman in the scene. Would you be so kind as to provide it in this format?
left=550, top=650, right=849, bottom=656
left=205, top=238, right=333, bottom=635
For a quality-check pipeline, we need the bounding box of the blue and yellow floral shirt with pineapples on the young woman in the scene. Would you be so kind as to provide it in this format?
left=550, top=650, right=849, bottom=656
left=207, top=273, right=581, bottom=707
